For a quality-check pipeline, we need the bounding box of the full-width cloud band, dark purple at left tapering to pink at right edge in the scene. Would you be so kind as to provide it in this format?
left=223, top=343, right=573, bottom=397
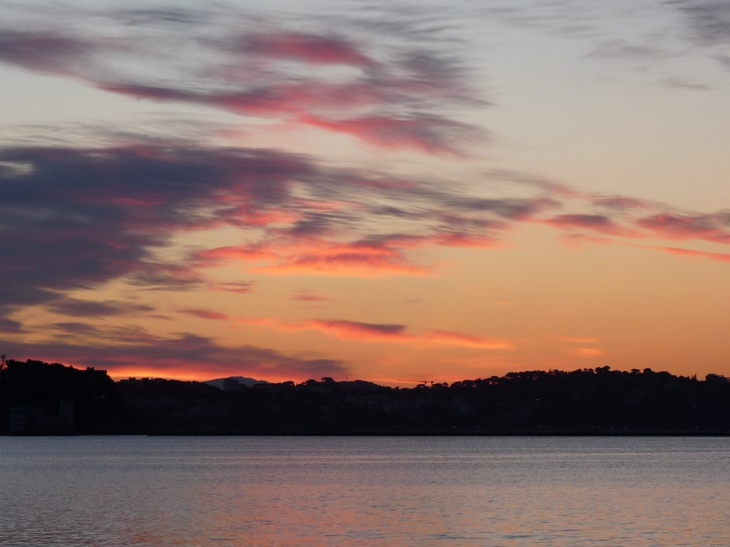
left=5, top=139, right=730, bottom=328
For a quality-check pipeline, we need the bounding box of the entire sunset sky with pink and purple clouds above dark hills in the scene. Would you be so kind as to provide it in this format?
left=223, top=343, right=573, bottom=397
left=0, top=0, right=730, bottom=387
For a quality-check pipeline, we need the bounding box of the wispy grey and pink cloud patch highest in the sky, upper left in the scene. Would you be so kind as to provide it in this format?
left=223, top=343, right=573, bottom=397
left=0, top=7, right=487, bottom=154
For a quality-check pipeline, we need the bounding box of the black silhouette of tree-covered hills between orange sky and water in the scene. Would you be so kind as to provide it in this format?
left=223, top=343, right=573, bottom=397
left=0, top=360, right=730, bottom=435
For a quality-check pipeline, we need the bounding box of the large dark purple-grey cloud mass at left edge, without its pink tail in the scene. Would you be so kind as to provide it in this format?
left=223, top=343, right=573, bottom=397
left=0, top=146, right=312, bottom=315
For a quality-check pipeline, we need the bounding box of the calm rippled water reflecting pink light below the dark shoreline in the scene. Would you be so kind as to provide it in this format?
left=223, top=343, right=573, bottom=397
left=0, top=437, right=730, bottom=547
